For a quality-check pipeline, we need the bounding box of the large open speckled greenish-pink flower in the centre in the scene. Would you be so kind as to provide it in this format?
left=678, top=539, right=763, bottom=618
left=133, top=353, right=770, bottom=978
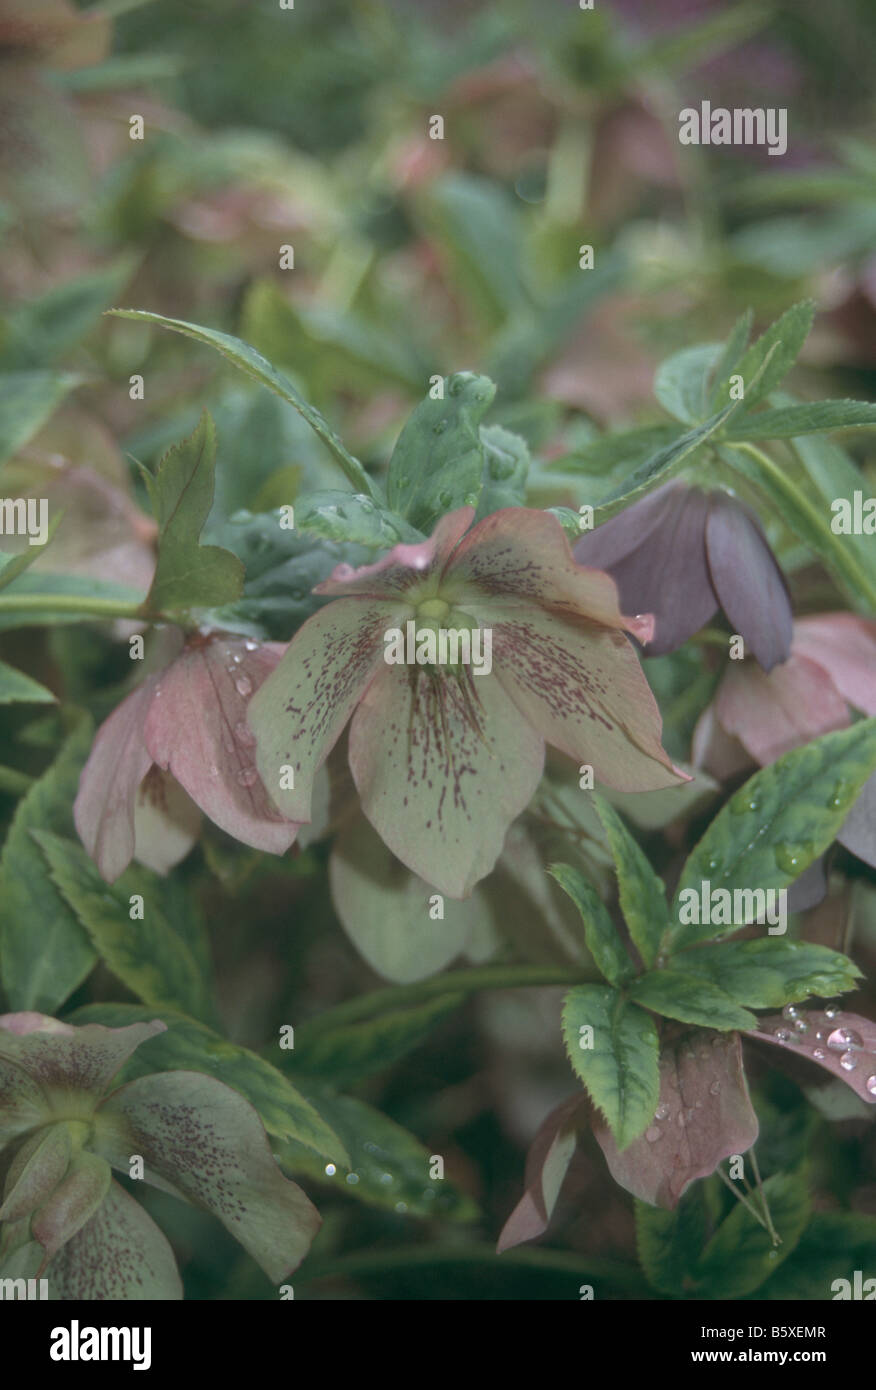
left=250, top=507, right=684, bottom=898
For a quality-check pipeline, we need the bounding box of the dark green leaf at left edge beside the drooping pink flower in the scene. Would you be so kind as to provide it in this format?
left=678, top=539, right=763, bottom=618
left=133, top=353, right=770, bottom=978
left=0, top=713, right=97, bottom=1013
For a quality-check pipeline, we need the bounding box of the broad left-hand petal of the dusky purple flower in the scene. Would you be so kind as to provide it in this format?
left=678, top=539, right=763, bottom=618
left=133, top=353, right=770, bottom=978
left=574, top=487, right=717, bottom=656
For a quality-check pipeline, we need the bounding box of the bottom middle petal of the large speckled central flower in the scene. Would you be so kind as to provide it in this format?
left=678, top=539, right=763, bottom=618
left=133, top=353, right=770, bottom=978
left=349, top=666, right=544, bottom=898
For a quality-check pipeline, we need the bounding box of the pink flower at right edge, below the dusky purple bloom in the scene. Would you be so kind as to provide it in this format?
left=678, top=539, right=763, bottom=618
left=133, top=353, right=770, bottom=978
left=692, top=613, right=876, bottom=867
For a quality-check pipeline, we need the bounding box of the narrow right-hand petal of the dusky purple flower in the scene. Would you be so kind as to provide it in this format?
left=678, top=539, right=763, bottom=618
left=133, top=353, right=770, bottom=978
left=705, top=492, right=794, bottom=671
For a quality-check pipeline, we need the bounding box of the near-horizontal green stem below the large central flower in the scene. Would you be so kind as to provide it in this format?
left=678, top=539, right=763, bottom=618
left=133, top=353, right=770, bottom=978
left=294, top=965, right=598, bottom=1037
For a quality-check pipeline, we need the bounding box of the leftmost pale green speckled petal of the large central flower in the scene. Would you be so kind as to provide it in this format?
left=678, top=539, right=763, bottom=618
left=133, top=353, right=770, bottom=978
left=249, top=598, right=412, bottom=821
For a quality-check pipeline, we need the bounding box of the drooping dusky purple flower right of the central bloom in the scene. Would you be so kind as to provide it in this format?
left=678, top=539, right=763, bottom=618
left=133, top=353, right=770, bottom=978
left=574, top=482, right=793, bottom=671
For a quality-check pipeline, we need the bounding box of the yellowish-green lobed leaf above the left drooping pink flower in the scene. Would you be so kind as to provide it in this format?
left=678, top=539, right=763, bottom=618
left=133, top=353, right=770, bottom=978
left=146, top=411, right=243, bottom=613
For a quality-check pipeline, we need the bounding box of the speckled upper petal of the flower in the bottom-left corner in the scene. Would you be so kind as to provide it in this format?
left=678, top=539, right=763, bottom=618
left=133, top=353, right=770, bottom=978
left=0, top=1013, right=167, bottom=1100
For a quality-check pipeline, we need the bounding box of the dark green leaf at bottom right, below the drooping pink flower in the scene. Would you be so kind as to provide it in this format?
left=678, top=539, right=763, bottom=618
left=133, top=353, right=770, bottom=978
left=697, top=1173, right=809, bottom=1298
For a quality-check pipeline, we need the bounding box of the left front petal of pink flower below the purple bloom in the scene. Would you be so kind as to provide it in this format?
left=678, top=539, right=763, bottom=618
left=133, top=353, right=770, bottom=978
left=715, top=656, right=848, bottom=766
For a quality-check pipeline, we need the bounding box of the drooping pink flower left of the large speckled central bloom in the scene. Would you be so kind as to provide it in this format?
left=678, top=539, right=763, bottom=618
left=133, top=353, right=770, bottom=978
left=74, top=634, right=298, bottom=883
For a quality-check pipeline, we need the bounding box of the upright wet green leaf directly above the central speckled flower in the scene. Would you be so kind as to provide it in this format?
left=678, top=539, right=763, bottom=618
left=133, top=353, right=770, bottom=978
left=387, top=371, right=496, bottom=534
